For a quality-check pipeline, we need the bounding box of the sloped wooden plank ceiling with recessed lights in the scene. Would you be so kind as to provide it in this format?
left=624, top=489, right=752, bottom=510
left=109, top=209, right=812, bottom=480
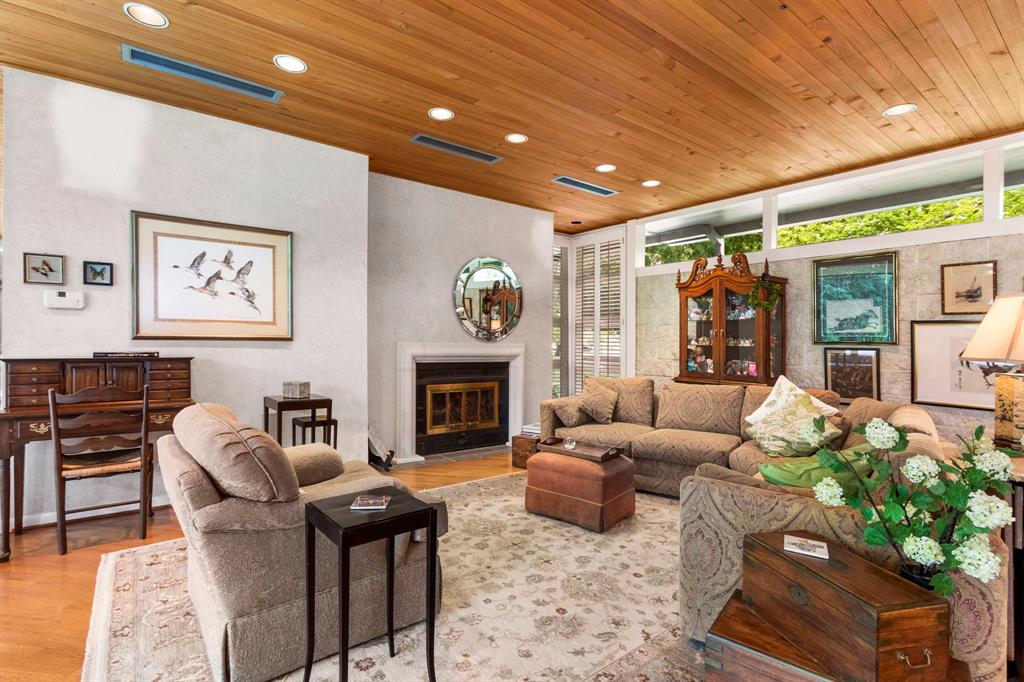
left=0, top=0, right=1024, bottom=232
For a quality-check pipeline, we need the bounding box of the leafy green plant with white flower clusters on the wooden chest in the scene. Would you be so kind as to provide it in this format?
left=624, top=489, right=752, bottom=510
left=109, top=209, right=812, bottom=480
left=813, top=417, right=1020, bottom=595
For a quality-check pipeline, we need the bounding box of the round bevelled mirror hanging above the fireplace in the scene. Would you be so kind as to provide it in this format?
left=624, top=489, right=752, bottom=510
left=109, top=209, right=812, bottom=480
left=455, top=258, right=522, bottom=341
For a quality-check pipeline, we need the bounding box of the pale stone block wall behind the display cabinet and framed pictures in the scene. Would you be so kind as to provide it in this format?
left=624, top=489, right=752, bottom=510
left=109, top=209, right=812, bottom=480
left=636, top=227, right=1024, bottom=438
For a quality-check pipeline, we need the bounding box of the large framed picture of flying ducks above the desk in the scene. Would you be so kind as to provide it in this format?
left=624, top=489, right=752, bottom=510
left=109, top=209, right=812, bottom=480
left=131, top=211, right=292, bottom=340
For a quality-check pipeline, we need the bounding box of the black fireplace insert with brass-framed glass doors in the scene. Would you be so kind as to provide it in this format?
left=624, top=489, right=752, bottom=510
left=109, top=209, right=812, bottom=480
left=416, top=363, right=509, bottom=456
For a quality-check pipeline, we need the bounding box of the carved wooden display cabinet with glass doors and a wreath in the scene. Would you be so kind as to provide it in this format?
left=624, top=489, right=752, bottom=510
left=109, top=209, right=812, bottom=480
left=676, top=253, right=786, bottom=385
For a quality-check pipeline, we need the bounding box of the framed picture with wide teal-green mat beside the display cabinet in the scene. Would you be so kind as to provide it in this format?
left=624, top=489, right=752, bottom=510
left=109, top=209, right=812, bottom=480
left=814, top=252, right=898, bottom=344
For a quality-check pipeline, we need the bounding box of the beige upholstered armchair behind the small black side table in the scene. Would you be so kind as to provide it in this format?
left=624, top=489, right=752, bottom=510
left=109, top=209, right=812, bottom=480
left=157, top=404, right=446, bottom=681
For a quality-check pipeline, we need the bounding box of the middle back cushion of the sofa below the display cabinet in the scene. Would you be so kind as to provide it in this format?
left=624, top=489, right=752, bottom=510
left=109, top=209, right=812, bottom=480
left=656, top=383, right=745, bottom=436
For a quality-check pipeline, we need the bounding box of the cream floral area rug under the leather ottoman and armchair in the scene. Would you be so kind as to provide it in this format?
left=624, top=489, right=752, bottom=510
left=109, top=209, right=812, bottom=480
left=82, top=474, right=702, bottom=682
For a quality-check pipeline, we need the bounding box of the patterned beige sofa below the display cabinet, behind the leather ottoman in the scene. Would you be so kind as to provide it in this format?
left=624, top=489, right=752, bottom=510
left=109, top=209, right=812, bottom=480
left=541, top=377, right=839, bottom=497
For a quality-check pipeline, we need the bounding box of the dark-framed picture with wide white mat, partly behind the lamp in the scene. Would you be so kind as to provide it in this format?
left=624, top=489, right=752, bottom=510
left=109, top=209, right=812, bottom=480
left=910, top=319, right=1013, bottom=410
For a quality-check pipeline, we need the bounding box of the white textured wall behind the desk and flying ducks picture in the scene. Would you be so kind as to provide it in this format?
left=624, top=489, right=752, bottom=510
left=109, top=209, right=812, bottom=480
left=0, top=69, right=368, bottom=522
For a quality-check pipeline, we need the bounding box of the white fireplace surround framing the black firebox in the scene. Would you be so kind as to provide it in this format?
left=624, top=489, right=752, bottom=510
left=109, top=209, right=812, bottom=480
left=394, top=341, right=526, bottom=464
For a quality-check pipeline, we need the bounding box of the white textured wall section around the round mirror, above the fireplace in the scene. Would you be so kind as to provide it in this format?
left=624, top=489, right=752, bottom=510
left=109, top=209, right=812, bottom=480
left=369, top=174, right=554, bottom=449
